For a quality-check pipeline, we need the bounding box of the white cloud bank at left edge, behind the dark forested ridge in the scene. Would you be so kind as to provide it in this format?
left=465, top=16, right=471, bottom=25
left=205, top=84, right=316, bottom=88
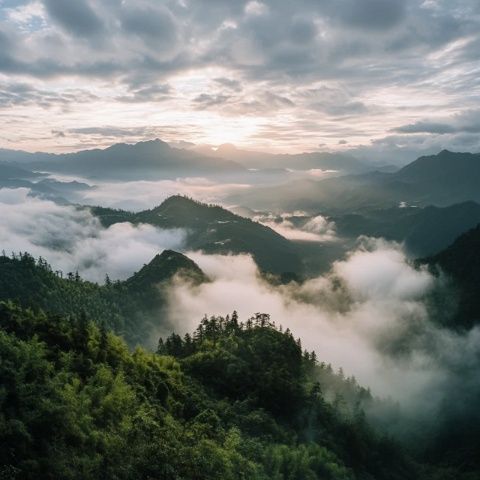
left=0, top=188, right=185, bottom=283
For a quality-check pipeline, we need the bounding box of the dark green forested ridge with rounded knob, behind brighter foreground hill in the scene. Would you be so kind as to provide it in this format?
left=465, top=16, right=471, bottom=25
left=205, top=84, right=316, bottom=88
left=0, top=250, right=207, bottom=345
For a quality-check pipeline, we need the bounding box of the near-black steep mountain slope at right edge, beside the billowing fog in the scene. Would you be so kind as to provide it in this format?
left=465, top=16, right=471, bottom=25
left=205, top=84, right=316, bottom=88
left=419, top=224, right=480, bottom=328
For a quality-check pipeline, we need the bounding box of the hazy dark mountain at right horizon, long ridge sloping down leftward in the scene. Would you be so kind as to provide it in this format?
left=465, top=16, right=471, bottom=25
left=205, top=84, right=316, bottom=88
left=229, top=150, right=480, bottom=214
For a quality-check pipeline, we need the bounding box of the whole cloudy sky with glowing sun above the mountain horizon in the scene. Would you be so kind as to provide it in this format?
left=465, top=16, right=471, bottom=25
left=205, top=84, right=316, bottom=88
left=0, top=0, right=480, bottom=156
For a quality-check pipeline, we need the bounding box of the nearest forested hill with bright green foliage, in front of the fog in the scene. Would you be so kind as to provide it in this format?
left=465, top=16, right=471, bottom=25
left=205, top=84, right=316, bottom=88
left=0, top=303, right=432, bottom=480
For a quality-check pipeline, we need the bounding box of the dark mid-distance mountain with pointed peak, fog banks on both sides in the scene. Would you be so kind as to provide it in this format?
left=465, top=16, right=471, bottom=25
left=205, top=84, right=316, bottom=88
left=91, top=195, right=302, bottom=274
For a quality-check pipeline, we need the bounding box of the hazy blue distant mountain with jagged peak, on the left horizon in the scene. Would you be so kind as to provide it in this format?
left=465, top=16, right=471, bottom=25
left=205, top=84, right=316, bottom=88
left=0, top=139, right=246, bottom=180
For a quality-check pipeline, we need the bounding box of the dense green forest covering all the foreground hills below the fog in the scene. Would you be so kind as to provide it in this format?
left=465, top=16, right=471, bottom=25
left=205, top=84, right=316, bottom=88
left=0, top=246, right=480, bottom=480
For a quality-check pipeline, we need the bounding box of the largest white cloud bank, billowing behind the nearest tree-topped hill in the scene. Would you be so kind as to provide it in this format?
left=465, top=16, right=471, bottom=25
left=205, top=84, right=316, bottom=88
left=164, top=239, right=480, bottom=414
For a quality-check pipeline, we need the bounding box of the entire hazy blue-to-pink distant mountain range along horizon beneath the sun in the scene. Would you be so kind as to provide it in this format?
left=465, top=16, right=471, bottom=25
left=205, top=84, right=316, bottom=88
left=0, top=139, right=380, bottom=181
